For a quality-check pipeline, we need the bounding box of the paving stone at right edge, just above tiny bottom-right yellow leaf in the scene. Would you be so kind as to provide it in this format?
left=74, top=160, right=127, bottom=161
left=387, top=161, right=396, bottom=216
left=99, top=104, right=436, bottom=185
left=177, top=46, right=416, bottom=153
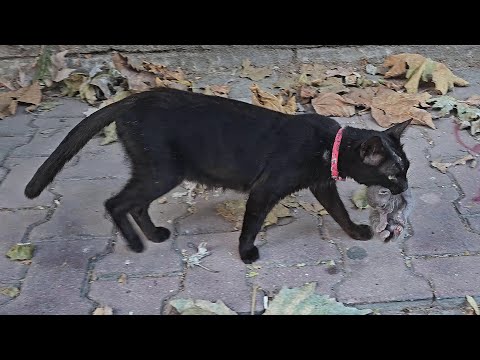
left=412, top=256, right=480, bottom=298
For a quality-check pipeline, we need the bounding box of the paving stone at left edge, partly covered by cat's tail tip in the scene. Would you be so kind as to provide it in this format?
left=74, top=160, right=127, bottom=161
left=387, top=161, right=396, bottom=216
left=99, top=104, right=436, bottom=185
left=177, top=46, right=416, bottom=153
left=0, top=157, right=54, bottom=209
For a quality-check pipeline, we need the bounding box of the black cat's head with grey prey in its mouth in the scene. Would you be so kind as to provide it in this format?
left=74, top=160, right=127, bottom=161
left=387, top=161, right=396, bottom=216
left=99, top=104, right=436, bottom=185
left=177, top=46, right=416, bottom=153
left=346, top=120, right=411, bottom=195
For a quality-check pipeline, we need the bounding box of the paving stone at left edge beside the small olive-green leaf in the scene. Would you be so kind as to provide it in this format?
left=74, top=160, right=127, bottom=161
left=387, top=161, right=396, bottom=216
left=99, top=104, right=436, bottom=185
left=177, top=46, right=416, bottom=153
left=0, top=210, right=47, bottom=282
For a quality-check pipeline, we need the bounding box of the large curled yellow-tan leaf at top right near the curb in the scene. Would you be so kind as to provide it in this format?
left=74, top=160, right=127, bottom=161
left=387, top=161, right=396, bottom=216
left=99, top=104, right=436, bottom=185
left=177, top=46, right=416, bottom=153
left=383, top=54, right=468, bottom=95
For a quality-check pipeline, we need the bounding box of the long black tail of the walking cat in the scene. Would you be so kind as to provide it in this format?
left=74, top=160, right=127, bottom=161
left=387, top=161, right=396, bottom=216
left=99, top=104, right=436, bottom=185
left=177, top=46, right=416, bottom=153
left=25, top=98, right=134, bottom=199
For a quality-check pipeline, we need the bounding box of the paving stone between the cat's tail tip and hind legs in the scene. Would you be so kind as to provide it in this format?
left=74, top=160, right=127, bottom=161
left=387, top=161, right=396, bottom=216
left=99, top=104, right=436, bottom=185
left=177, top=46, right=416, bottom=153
left=30, top=180, right=120, bottom=241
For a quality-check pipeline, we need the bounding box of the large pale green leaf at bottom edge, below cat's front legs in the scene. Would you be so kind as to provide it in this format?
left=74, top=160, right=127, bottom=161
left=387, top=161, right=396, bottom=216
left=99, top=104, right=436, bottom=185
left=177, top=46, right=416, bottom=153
left=264, top=282, right=372, bottom=315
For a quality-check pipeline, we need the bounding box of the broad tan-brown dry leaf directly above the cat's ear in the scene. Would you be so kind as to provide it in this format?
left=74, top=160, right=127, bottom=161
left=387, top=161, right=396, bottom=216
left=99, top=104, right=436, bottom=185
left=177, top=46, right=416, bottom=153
left=371, top=87, right=435, bottom=129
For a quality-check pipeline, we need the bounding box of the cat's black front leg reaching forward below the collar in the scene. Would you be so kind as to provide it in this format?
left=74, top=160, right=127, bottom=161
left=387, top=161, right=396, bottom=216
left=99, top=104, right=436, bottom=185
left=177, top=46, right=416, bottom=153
left=310, top=180, right=373, bottom=240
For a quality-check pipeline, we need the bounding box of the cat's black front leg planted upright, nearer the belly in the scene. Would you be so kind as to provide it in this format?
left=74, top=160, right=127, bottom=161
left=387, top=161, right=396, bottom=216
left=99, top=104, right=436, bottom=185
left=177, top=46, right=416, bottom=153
left=239, top=189, right=280, bottom=264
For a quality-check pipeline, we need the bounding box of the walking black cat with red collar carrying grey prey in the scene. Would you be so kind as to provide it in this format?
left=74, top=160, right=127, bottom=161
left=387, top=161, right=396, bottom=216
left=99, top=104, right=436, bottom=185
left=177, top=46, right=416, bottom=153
left=25, top=88, right=409, bottom=264
